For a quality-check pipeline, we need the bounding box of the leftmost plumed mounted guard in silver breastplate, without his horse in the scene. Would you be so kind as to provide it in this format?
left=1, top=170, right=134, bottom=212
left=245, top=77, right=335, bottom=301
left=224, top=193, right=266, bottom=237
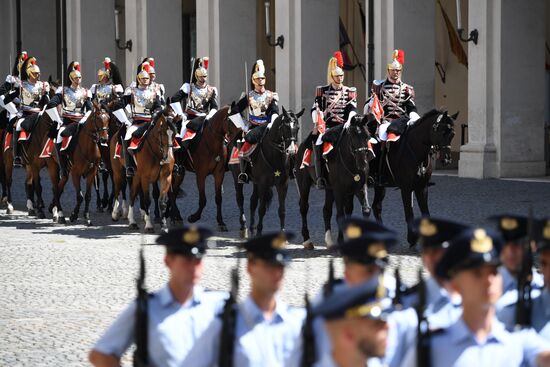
left=5, top=57, right=50, bottom=167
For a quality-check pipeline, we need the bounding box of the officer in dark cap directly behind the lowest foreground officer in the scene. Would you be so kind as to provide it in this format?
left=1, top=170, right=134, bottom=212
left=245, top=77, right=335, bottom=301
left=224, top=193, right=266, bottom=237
left=313, top=217, right=398, bottom=366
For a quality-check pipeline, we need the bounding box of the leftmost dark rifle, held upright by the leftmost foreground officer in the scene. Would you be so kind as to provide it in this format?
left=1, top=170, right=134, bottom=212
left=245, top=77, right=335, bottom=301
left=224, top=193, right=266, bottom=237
left=134, top=248, right=149, bottom=367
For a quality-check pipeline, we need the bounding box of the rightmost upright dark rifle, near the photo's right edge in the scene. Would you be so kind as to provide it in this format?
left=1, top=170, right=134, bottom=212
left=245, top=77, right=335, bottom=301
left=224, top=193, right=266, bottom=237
left=515, top=207, right=535, bottom=329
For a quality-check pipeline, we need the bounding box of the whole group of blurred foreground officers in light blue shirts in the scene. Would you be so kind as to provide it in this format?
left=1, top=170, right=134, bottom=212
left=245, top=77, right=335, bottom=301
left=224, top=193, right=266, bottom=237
left=89, top=214, right=550, bottom=367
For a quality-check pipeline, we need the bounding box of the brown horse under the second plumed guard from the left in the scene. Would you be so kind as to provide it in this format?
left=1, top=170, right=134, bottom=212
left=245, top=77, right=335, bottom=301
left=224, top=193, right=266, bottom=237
left=54, top=101, right=109, bottom=226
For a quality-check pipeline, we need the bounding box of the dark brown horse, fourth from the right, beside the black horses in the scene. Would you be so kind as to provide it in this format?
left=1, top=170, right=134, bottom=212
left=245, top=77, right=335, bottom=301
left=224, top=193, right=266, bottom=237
left=170, top=106, right=237, bottom=232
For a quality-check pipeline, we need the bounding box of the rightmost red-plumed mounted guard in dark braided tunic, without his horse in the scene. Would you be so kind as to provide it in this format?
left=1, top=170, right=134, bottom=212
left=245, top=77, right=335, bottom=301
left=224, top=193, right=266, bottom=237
left=364, top=50, right=420, bottom=185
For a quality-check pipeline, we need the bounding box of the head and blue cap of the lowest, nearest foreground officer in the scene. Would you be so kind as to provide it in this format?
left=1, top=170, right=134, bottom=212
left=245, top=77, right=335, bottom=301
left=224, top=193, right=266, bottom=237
left=312, top=278, right=391, bottom=367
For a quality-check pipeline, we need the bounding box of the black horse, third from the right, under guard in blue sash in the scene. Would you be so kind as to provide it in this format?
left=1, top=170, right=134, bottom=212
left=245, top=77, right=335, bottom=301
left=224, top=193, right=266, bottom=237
left=230, top=107, right=304, bottom=237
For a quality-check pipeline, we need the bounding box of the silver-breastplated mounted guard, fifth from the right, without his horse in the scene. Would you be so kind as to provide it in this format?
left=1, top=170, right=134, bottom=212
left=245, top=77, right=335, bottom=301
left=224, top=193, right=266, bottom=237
left=113, top=61, right=162, bottom=177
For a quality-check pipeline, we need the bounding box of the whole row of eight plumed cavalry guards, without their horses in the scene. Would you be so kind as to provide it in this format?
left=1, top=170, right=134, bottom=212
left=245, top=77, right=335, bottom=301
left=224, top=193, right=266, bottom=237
left=0, top=50, right=419, bottom=188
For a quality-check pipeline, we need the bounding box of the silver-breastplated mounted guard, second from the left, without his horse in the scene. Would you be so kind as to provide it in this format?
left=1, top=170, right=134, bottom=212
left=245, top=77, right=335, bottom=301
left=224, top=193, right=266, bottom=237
left=46, top=61, right=92, bottom=177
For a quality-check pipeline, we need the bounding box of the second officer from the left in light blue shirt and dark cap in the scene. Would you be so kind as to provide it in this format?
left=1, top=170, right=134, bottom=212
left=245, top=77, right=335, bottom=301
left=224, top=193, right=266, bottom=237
left=182, top=232, right=305, bottom=367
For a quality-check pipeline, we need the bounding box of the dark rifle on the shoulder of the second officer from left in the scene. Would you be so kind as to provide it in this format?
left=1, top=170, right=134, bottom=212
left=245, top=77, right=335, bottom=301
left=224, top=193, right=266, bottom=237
left=218, top=258, right=240, bottom=367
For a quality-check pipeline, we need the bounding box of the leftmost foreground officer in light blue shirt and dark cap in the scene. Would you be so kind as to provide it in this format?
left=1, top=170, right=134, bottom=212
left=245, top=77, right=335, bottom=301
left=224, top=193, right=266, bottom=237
left=89, top=225, right=227, bottom=367
